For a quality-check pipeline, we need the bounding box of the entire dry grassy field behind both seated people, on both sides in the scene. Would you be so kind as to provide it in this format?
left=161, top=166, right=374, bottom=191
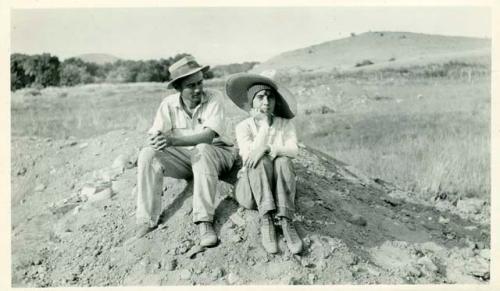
left=12, top=72, right=490, bottom=202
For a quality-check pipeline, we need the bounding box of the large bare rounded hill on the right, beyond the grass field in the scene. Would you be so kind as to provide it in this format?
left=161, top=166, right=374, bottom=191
left=254, top=32, right=491, bottom=72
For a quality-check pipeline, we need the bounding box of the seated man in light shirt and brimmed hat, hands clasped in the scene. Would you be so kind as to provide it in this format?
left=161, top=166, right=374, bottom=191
left=136, top=56, right=237, bottom=246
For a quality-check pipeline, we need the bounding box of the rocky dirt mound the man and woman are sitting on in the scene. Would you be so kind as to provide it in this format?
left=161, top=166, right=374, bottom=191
left=12, top=131, right=490, bottom=287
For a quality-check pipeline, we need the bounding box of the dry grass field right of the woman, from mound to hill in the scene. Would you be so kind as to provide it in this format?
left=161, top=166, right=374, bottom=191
left=293, top=71, right=490, bottom=202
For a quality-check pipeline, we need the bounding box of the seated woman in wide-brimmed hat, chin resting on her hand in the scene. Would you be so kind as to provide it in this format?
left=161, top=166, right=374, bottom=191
left=226, top=73, right=303, bottom=254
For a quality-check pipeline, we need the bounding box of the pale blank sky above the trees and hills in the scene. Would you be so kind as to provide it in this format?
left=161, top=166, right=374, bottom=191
left=11, top=7, right=491, bottom=65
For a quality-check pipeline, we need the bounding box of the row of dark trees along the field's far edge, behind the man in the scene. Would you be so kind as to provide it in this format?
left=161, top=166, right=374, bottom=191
left=10, top=53, right=257, bottom=91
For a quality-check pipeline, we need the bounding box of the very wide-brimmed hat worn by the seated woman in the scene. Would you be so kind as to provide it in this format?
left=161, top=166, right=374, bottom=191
left=226, top=73, right=297, bottom=119
